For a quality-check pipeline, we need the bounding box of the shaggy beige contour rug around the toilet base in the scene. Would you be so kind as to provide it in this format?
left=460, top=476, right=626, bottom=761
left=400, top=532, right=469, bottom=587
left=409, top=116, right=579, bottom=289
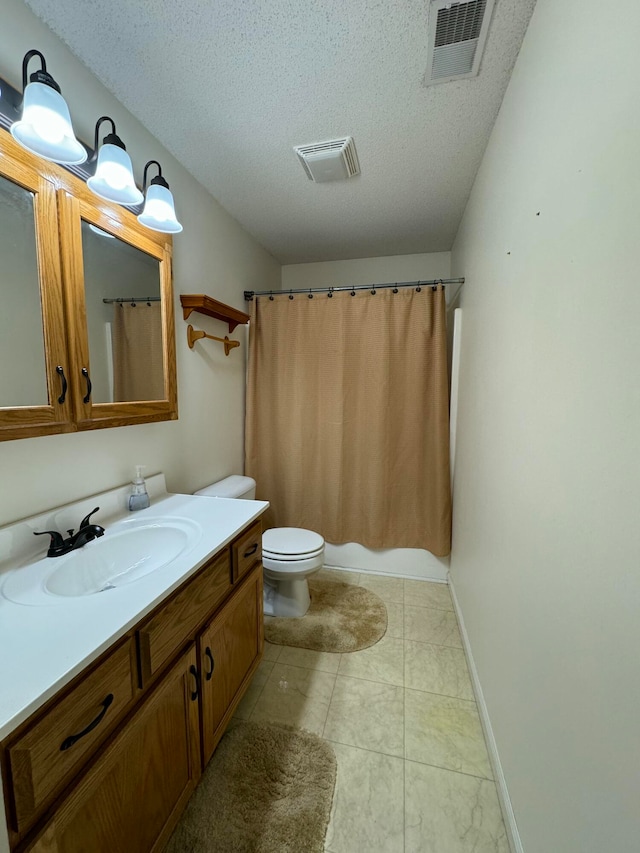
left=264, top=577, right=387, bottom=652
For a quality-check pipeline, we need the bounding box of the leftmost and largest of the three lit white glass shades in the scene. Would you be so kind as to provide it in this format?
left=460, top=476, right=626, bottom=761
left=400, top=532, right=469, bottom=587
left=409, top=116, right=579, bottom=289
left=11, top=83, right=87, bottom=165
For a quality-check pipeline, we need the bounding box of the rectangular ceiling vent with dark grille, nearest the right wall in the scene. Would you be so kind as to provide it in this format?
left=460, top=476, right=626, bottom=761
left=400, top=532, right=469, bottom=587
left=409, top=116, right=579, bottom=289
left=424, top=0, right=494, bottom=86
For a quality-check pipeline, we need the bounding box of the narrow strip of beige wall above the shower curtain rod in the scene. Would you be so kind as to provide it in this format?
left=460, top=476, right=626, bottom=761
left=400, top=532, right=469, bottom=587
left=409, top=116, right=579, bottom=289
left=282, top=252, right=451, bottom=290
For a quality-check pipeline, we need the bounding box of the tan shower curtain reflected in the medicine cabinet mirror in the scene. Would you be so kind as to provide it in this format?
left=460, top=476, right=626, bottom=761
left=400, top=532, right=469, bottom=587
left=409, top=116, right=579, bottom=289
left=113, top=302, right=165, bottom=403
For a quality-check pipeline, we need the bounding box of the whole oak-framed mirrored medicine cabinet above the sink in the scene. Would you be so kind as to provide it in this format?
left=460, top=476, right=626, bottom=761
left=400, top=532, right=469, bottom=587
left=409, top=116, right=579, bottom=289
left=0, top=130, right=178, bottom=440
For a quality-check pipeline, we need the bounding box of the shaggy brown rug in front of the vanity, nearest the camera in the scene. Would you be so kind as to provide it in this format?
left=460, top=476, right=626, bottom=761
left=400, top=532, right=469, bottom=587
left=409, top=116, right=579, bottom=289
left=165, top=723, right=336, bottom=853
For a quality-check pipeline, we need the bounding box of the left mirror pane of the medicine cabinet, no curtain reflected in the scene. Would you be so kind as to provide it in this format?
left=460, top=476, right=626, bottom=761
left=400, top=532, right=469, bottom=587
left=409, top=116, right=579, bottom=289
left=0, top=176, right=49, bottom=408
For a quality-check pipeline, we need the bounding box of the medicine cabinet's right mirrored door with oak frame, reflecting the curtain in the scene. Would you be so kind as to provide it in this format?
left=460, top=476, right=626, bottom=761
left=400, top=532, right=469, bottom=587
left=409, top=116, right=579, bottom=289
left=60, top=192, right=176, bottom=429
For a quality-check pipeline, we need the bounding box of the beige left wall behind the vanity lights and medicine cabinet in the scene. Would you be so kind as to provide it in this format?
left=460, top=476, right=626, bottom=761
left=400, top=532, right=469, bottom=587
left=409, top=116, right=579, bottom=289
left=0, top=0, right=280, bottom=524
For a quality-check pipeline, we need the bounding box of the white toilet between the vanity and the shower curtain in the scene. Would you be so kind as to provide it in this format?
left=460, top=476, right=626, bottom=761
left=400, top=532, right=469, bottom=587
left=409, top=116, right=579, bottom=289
left=195, top=474, right=324, bottom=616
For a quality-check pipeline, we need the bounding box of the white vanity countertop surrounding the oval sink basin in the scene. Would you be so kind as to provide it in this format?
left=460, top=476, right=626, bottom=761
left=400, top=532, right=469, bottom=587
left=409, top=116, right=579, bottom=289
left=0, top=479, right=269, bottom=744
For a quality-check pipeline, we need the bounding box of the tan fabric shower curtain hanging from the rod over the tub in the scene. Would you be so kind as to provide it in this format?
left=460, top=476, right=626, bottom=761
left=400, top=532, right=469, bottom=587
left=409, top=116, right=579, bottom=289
left=245, top=287, right=451, bottom=556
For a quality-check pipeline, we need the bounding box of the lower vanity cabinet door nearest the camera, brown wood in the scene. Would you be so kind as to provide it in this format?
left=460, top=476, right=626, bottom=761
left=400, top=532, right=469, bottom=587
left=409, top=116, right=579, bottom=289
left=27, top=646, right=200, bottom=853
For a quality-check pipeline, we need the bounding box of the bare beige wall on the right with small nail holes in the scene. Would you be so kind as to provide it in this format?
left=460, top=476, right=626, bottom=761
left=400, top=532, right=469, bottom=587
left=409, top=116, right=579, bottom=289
left=451, top=0, right=640, bottom=853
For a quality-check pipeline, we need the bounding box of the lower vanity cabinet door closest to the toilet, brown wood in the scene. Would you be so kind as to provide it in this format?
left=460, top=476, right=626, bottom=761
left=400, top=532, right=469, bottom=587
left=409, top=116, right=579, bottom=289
left=198, top=565, right=263, bottom=764
